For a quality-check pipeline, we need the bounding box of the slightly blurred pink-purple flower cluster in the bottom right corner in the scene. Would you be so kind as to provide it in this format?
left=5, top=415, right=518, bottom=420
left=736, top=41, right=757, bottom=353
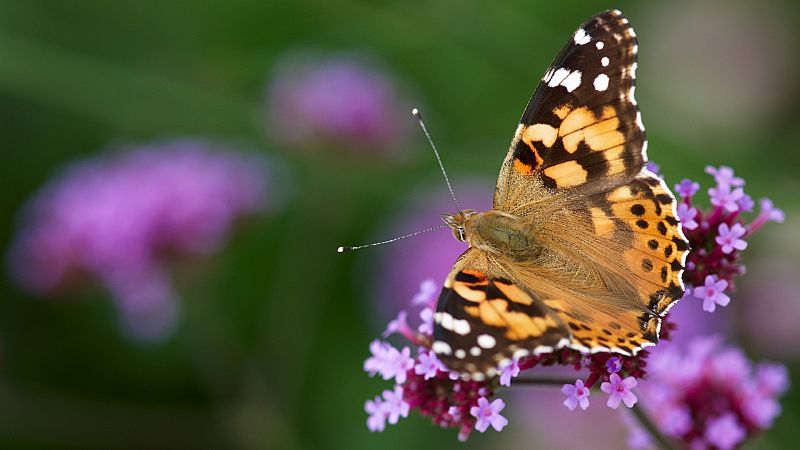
left=634, top=336, right=789, bottom=450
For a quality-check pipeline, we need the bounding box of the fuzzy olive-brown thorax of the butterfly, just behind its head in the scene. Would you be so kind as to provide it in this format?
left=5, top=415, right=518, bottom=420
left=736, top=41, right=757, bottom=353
left=465, top=210, right=542, bottom=261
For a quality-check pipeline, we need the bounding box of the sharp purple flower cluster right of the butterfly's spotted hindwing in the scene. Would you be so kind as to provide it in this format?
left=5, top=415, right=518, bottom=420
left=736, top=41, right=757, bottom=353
left=675, top=166, right=784, bottom=300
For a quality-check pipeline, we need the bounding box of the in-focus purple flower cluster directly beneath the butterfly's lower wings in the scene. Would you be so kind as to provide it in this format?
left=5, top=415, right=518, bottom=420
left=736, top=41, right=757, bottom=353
left=364, top=280, right=660, bottom=440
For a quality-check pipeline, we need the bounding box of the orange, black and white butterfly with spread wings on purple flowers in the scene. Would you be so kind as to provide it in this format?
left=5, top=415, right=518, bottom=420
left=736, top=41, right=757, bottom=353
left=431, top=10, right=689, bottom=380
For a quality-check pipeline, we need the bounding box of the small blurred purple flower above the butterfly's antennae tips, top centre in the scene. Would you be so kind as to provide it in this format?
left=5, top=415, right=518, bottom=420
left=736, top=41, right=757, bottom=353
left=267, top=52, right=412, bottom=154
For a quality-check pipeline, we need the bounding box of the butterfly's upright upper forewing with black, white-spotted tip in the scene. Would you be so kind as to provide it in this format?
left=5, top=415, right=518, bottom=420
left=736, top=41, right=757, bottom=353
left=494, top=11, right=646, bottom=209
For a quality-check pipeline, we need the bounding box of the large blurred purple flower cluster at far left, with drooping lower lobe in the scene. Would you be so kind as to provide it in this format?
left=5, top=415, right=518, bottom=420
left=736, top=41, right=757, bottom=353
left=8, top=140, right=276, bottom=339
